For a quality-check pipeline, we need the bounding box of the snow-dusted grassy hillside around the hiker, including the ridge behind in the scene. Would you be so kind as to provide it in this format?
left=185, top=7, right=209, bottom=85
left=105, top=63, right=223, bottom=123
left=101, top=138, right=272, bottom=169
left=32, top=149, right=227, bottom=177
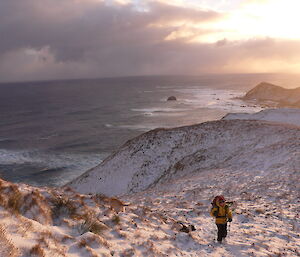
left=0, top=110, right=300, bottom=257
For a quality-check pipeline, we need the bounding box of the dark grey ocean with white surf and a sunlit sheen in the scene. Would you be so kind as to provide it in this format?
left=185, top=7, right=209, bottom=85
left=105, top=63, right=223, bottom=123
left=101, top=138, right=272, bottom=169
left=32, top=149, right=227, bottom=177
left=0, top=74, right=300, bottom=186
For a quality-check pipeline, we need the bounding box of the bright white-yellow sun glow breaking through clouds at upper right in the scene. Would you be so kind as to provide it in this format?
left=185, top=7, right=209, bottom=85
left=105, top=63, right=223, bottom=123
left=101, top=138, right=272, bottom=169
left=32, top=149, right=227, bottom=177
left=164, top=0, right=300, bottom=43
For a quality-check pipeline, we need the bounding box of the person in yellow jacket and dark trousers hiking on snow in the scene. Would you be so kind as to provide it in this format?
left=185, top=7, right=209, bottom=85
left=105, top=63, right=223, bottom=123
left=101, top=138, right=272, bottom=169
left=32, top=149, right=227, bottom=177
left=210, top=195, right=232, bottom=243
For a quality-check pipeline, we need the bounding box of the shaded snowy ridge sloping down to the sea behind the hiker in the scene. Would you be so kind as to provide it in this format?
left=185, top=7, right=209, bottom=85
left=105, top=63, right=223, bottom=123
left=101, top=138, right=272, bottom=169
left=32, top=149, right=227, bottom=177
left=68, top=115, right=300, bottom=195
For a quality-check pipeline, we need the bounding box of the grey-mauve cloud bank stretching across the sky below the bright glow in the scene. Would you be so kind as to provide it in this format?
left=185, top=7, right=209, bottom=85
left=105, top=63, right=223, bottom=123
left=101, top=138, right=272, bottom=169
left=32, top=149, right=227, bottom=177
left=0, top=0, right=300, bottom=81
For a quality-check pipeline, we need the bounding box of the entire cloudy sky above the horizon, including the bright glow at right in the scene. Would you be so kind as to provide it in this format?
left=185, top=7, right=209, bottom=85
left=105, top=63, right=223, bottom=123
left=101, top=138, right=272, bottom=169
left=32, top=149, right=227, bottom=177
left=0, top=0, right=300, bottom=82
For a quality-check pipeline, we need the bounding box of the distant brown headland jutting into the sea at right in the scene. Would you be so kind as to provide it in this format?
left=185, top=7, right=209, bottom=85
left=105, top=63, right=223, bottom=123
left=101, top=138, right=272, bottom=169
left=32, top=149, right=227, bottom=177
left=242, top=82, right=300, bottom=108
